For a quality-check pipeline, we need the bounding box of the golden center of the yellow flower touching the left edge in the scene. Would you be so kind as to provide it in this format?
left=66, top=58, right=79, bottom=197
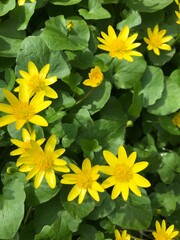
left=13, top=102, right=35, bottom=122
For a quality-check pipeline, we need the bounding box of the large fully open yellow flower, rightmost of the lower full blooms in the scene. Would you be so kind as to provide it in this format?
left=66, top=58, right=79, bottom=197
left=100, top=146, right=151, bottom=201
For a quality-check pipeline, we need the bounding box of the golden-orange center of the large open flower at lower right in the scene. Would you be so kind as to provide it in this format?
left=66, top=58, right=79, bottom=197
left=114, top=163, right=133, bottom=183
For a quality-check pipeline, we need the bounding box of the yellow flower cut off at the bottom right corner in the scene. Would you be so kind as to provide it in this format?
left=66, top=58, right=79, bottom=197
left=152, top=220, right=179, bottom=240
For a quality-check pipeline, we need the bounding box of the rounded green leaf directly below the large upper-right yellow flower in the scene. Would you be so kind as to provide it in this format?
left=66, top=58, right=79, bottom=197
left=113, top=57, right=146, bottom=89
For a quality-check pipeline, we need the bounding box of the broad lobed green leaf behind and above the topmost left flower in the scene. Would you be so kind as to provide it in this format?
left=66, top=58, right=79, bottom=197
left=16, top=36, right=70, bottom=78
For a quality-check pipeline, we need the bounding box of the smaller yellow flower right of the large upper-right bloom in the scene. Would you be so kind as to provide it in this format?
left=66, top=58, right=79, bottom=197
left=144, top=25, right=172, bottom=55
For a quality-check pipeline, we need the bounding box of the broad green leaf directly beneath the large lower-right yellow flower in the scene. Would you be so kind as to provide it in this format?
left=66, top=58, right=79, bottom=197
left=109, top=189, right=152, bottom=230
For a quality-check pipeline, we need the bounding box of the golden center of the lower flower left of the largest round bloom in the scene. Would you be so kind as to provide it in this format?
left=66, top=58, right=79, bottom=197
left=77, top=171, right=93, bottom=189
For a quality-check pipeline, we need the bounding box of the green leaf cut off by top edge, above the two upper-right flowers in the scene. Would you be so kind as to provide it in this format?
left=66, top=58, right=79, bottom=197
left=125, top=0, right=172, bottom=12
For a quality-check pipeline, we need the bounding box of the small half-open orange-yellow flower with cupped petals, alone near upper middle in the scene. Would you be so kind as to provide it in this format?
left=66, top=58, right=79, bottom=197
left=83, top=66, right=103, bottom=87
